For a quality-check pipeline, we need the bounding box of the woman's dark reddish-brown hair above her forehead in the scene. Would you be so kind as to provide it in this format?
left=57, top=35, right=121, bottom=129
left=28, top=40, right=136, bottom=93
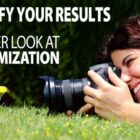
left=104, top=16, right=140, bottom=60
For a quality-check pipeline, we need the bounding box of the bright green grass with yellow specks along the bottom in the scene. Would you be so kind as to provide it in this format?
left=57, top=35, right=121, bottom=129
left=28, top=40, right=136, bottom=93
left=0, top=107, right=140, bottom=140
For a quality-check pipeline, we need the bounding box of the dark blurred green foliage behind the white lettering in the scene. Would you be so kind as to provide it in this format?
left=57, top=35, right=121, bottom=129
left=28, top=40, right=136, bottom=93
left=0, top=0, right=140, bottom=105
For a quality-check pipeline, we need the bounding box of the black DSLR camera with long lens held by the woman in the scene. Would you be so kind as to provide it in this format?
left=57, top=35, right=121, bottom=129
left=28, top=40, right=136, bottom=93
left=39, top=63, right=120, bottom=113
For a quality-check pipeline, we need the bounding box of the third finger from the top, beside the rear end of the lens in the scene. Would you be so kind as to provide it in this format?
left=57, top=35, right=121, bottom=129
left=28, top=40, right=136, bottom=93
left=83, top=86, right=100, bottom=98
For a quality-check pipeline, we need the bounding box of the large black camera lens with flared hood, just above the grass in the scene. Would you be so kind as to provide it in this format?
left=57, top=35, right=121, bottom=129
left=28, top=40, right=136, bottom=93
left=40, top=76, right=88, bottom=112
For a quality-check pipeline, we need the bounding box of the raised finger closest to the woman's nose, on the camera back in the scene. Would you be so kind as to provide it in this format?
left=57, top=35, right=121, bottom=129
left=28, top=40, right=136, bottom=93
left=108, top=67, right=124, bottom=87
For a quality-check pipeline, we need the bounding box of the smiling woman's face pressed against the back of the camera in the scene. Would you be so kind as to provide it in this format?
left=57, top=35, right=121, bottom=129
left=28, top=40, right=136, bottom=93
left=111, top=49, right=140, bottom=94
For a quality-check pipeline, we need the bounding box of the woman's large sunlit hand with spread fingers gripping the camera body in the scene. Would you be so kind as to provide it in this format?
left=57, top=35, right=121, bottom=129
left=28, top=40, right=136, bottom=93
left=84, top=68, right=134, bottom=119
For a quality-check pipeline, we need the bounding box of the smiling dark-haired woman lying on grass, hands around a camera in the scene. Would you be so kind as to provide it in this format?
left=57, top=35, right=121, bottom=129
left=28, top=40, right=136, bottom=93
left=70, top=16, right=140, bottom=122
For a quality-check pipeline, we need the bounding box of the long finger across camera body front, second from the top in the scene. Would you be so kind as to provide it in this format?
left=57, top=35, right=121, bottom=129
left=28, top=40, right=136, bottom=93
left=88, top=70, right=109, bottom=88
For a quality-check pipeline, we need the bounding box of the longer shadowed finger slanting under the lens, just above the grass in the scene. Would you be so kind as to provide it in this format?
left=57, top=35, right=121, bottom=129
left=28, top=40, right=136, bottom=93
left=77, top=104, right=93, bottom=115
